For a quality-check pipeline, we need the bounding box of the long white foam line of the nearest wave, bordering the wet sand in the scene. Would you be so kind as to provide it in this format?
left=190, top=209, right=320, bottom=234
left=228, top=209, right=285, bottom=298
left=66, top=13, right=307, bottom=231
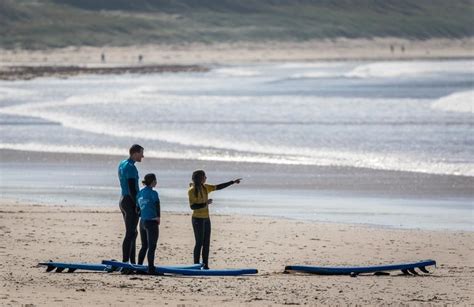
left=0, top=143, right=474, bottom=176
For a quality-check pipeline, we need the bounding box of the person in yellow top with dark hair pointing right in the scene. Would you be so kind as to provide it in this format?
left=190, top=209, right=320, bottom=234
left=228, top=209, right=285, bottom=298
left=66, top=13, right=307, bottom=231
left=188, top=170, right=242, bottom=270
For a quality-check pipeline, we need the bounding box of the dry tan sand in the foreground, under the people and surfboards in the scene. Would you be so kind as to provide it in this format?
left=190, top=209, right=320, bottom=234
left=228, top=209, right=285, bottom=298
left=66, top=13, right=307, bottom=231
left=0, top=200, right=474, bottom=306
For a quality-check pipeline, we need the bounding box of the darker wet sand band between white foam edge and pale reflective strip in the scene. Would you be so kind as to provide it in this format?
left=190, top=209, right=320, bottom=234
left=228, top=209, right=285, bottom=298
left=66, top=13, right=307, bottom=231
left=0, top=149, right=474, bottom=199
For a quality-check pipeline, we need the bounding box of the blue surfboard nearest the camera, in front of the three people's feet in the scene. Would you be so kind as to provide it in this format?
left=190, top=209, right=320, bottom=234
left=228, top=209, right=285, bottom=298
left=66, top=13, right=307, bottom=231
left=102, top=260, right=258, bottom=276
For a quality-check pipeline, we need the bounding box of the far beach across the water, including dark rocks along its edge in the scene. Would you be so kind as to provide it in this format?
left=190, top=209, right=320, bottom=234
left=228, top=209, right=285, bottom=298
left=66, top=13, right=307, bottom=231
left=0, top=38, right=474, bottom=80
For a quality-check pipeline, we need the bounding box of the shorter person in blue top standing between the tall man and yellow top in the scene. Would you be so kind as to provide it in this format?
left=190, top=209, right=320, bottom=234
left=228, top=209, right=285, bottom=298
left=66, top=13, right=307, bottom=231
left=137, top=174, right=161, bottom=275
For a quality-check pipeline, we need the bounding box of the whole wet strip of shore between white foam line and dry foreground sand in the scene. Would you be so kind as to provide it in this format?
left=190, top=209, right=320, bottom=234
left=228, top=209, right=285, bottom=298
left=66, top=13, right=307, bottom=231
left=0, top=149, right=474, bottom=231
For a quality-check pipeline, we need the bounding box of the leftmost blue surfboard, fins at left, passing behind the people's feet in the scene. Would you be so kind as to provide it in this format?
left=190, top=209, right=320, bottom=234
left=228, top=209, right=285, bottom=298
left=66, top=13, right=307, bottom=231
left=38, top=261, right=201, bottom=273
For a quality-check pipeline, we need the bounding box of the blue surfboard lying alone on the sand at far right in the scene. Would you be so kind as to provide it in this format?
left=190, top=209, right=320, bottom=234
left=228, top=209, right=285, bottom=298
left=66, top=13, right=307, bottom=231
left=285, top=259, right=436, bottom=275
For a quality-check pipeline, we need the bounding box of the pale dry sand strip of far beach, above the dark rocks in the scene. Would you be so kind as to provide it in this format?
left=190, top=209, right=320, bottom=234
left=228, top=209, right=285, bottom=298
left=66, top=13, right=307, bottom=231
left=0, top=38, right=474, bottom=67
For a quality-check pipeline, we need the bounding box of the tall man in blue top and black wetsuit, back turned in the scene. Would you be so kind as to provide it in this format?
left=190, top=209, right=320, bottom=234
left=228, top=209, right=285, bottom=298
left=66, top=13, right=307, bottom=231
left=118, top=144, right=144, bottom=263
